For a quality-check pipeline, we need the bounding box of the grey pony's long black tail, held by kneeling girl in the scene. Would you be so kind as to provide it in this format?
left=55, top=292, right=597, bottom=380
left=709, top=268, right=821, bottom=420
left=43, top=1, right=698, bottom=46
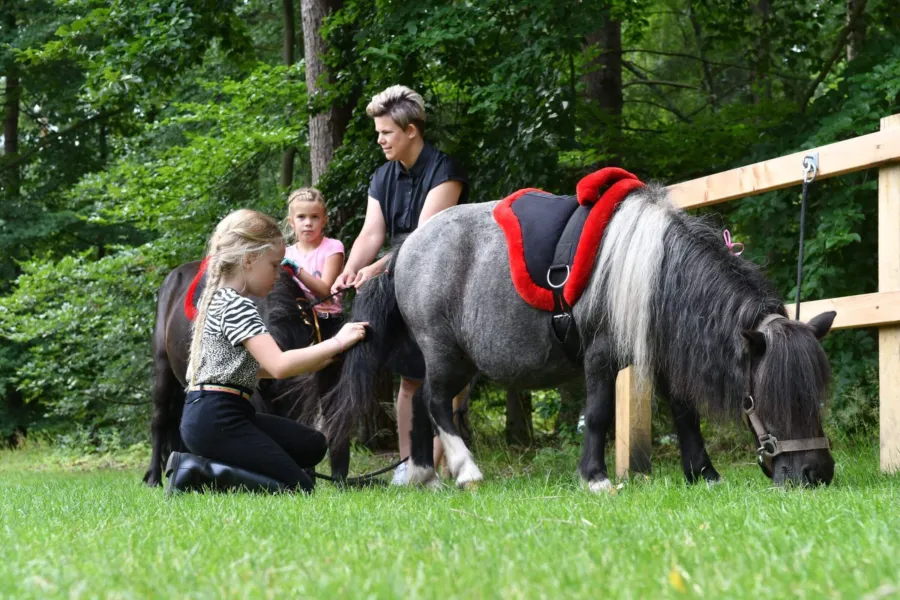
left=322, top=248, right=409, bottom=440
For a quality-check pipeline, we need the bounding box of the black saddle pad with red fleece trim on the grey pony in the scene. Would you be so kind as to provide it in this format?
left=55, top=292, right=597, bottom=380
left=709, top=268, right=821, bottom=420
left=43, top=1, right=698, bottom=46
left=494, top=167, right=644, bottom=311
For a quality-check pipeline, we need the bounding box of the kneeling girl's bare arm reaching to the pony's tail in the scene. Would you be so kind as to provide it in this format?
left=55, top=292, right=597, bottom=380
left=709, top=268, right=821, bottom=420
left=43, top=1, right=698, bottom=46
left=243, top=323, right=368, bottom=379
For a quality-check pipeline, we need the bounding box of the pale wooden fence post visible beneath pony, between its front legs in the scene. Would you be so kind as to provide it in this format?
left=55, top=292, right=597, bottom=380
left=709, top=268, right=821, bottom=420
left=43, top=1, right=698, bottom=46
left=616, top=367, right=652, bottom=477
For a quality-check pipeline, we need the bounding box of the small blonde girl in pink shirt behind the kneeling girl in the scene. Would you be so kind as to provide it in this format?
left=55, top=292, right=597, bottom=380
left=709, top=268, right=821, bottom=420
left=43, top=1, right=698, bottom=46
left=284, top=188, right=344, bottom=332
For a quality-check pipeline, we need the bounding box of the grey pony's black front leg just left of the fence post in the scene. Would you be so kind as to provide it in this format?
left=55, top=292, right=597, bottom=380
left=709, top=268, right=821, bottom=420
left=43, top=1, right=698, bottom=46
left=578, top=351, right=617, bottom=493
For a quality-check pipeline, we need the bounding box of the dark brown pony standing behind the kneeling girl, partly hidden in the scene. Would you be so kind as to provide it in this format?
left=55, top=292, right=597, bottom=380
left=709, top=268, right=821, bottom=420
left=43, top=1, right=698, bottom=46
left=144, top=261, right=350, bottom=486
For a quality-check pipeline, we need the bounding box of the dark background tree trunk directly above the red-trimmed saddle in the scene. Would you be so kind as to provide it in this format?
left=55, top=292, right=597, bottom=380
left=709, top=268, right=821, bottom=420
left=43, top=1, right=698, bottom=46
left=582, top=9, right=622, bottom=167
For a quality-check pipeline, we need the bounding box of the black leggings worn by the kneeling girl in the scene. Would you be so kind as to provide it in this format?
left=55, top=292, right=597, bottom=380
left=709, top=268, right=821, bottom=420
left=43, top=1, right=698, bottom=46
left=181, top=391, right=328, bottom=492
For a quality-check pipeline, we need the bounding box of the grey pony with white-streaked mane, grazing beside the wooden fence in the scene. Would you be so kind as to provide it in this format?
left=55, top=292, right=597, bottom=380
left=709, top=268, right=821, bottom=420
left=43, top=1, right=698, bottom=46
left=325, top=186, right=834, bottom=492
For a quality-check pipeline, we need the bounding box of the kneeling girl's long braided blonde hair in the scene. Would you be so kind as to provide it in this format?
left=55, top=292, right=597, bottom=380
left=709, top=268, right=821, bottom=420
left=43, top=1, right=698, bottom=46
left=187, top=209, right=284, bottom=385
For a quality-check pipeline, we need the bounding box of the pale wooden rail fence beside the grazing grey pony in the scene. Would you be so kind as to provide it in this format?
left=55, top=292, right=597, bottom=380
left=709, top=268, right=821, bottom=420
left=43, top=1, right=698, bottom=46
left=616, top=114, right=900, bottom=477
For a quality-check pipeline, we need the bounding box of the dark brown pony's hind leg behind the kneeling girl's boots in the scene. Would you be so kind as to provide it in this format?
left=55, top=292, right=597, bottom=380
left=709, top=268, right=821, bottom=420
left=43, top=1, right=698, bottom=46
left=144, top=357, right=185, bottom=487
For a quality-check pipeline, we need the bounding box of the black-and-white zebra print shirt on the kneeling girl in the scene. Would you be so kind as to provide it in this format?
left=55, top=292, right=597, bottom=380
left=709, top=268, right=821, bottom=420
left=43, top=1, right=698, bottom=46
left=195, top=288, right=269, bottom=390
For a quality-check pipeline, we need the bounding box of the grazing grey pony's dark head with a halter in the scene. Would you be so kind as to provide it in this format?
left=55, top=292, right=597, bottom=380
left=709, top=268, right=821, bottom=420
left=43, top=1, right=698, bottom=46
left=742, top=312, right=835, bottom=485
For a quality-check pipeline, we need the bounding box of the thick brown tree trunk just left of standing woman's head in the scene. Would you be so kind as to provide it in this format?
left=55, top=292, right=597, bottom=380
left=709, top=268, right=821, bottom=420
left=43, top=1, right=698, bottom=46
left=300, top=0, right=349, bottom=185
